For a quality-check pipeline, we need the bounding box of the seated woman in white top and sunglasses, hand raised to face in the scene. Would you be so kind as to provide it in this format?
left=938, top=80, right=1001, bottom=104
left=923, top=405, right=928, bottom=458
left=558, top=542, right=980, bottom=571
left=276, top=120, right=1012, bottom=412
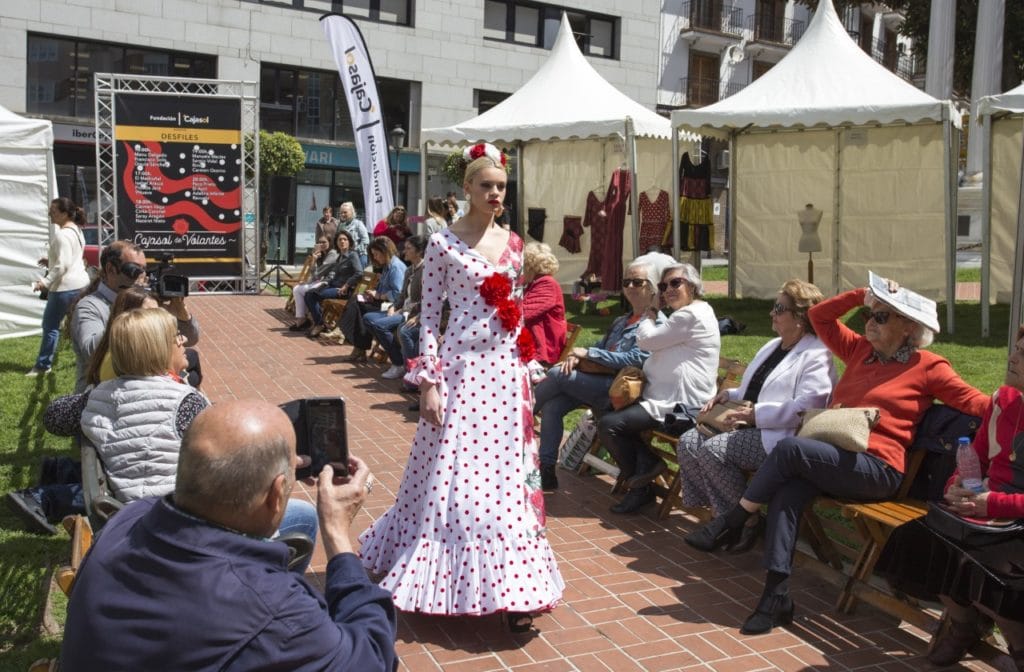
left=597, top=260, right=722, bottom=513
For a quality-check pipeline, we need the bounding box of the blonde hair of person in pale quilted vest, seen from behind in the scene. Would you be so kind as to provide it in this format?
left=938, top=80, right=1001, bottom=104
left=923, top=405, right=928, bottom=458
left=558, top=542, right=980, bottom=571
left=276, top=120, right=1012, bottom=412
left=110, top=308, right=178, bottom=376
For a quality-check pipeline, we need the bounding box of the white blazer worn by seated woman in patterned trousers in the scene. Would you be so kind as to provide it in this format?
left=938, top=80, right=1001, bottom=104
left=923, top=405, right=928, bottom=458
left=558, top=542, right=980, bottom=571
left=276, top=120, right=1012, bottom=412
left=729, top=334, right=836, bottom=453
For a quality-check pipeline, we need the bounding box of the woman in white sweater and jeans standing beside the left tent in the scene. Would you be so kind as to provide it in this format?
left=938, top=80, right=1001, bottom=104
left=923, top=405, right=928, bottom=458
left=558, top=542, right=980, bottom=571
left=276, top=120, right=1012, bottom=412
left=26, top=198, right=89, bottom=376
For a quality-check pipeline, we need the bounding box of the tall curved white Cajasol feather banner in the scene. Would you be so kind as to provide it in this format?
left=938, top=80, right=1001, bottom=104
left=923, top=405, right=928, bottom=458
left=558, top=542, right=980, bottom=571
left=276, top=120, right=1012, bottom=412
left=321, top=14, right=394, bottom=227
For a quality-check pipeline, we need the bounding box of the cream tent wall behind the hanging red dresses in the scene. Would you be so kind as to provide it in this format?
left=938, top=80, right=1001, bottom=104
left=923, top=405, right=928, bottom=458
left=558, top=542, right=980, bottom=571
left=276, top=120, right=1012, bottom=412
left=521, top=136, right=679, bottom=291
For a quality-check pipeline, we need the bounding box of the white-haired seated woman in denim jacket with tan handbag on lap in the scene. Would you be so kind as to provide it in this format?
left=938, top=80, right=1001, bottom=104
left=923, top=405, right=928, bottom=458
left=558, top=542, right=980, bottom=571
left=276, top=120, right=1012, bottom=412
left=534, top=254, right=673, bottom=490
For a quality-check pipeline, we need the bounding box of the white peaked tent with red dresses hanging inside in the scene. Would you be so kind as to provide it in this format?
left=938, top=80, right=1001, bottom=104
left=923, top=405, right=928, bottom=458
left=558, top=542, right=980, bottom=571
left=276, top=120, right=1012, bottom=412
left=420, top=13, right=694, bottom=289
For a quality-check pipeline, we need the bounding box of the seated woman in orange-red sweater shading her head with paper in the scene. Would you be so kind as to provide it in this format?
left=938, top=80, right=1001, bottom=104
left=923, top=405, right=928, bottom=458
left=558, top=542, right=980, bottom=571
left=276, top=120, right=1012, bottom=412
left=686, top=281, right=988, bottom=635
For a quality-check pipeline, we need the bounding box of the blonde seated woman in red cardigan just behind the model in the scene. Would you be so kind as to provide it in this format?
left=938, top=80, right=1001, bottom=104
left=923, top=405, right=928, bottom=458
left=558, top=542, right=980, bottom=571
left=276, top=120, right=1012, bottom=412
left=522, top=243, right=565, bottom=368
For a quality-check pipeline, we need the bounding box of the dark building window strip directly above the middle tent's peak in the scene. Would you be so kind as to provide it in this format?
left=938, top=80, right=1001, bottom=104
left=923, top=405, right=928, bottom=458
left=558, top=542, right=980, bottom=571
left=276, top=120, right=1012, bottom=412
left=483, top=0, right=618, bottom=58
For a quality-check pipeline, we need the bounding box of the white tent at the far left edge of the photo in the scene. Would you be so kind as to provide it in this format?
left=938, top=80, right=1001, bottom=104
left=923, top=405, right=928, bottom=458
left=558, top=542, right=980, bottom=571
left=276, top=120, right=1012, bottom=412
left=0, top=107, right=57, bottom=338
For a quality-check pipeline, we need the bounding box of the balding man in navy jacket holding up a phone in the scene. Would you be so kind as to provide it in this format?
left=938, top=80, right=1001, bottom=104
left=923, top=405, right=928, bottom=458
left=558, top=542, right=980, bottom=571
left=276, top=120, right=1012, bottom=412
left=60, top=401, right=397, bottom=672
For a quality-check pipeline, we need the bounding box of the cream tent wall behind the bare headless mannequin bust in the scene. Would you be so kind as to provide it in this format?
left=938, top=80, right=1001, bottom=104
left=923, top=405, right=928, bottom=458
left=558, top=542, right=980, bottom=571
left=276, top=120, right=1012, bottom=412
left=733, top=124, right=946, bottom=300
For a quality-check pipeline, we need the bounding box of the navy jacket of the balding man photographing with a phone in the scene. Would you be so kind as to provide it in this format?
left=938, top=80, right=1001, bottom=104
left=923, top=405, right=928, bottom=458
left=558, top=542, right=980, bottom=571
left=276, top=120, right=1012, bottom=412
left=60, top=497, right=397, bottom=672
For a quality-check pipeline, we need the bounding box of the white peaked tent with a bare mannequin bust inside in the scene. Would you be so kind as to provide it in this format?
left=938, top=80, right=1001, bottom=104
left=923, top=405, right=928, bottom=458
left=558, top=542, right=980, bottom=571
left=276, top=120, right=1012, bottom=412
left=672, top=0, right=959, bottom=331
